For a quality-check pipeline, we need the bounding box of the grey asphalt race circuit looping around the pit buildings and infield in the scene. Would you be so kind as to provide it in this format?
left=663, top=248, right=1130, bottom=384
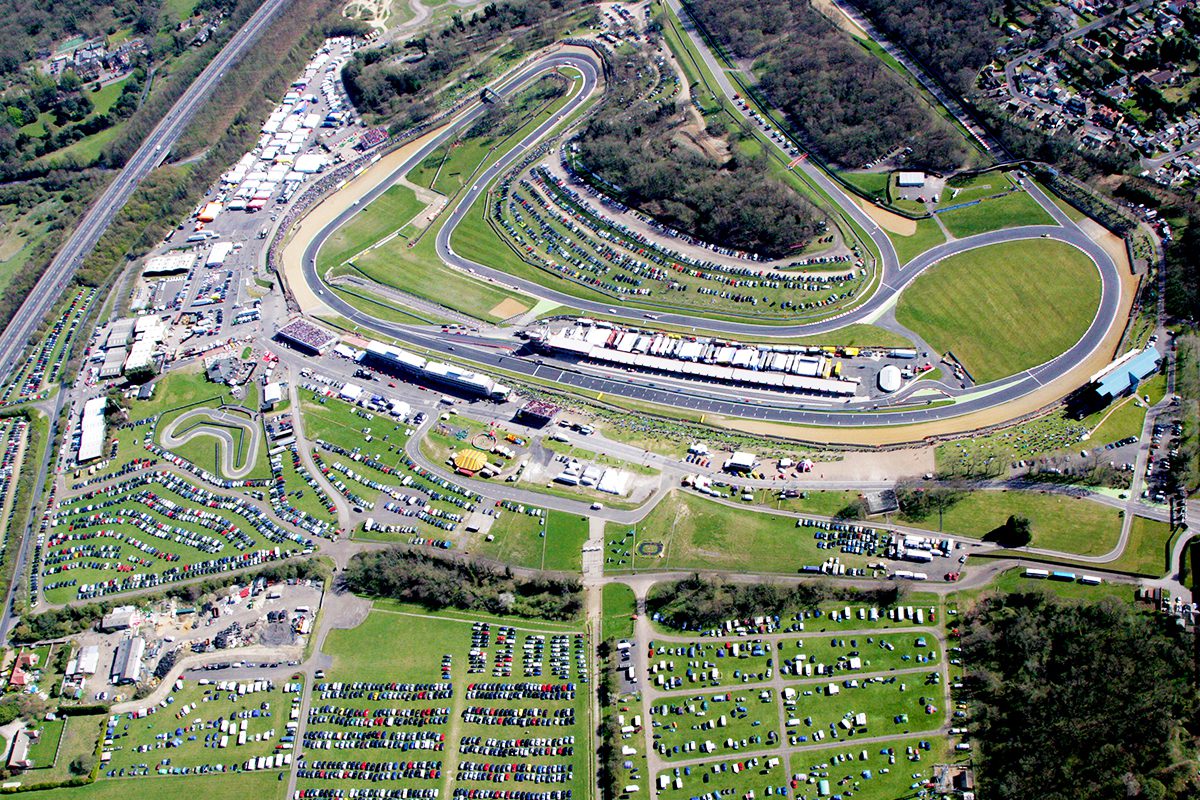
left=301, top=52, right=1121, bottom=427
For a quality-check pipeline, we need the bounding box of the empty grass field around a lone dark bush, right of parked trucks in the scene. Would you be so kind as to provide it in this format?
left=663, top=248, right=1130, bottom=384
left=901, top=491, right=1121, bottom=555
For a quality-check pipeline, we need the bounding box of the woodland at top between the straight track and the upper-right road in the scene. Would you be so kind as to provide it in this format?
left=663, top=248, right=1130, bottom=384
left=688, top=0, right=971, bottom=172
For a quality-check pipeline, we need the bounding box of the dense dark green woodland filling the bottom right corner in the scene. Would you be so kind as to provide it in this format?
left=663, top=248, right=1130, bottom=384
left=962, top=593, right=1200, bottom=800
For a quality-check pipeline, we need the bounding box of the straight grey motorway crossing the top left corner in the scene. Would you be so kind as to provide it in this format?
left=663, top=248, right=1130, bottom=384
left=0, top=0, right=292, bottom=373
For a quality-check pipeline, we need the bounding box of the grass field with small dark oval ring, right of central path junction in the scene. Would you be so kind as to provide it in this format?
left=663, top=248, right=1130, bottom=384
left=605, top=492, right=870, bottom=573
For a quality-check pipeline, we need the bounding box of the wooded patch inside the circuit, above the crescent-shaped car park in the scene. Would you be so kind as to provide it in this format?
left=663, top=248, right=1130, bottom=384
left=572, top=46, right=826, bottom=258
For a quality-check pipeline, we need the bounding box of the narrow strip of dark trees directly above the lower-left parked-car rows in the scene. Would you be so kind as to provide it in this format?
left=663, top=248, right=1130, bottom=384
left=341, top=547, right=583, bottom=620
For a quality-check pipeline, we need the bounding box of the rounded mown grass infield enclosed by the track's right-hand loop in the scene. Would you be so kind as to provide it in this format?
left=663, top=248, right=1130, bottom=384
left=896, top=240, right=1100, bottom=384
